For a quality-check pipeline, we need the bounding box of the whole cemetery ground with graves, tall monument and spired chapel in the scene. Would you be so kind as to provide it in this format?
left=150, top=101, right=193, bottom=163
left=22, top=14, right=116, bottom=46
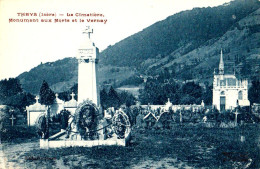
left=0, top=27, right=260, bottom=168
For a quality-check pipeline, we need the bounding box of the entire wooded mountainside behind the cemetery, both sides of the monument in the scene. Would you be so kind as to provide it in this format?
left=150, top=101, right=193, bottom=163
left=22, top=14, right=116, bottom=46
left=18, top=0, right=260, bottom=94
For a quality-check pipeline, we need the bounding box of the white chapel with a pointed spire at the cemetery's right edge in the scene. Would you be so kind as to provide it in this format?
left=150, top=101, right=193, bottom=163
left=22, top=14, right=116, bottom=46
left=212, top=50, right=250, bottom=111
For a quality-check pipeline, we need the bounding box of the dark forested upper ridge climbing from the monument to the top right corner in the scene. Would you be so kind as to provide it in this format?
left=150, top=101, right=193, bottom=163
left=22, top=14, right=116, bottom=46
left=101, top=0, right=260, bottom=69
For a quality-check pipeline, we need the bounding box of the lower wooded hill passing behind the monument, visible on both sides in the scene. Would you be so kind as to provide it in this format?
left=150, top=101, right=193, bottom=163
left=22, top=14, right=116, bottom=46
left=18, top=58, right=135, bottom=95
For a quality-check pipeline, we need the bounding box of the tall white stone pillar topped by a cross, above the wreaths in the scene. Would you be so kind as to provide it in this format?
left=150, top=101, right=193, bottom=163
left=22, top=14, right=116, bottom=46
left=77, top=26, right=100, bottom=106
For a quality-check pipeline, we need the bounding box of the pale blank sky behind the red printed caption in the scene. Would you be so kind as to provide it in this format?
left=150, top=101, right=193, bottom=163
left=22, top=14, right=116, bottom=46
left=0, top=0, right=230, bottom=80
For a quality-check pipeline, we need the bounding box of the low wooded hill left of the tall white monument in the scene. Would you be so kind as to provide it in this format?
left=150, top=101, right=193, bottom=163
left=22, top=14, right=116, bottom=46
left=18, top=58, right=78, bottom=94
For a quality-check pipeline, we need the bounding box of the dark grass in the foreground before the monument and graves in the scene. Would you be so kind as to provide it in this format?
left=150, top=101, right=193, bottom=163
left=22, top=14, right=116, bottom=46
left=2, top=125, right=260, bottom=168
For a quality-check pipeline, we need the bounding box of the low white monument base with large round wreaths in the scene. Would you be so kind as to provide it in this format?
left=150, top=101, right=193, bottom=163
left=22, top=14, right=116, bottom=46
left=40, top=100, right=131, bottom=149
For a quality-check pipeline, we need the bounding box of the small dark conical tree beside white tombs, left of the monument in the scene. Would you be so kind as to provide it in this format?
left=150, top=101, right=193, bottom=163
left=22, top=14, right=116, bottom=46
left=40, top=80, right=55, bottom=106
